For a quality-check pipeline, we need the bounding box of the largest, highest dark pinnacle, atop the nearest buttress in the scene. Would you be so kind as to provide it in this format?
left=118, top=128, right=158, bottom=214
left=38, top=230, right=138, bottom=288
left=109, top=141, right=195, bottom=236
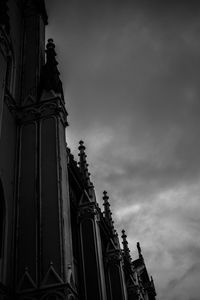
left=41, top=39, right=64, bottom=100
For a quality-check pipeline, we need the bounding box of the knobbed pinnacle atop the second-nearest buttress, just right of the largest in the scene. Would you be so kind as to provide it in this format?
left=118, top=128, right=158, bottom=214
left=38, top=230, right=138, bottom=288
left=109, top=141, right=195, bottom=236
left=78, top=141, right=93, bottom=187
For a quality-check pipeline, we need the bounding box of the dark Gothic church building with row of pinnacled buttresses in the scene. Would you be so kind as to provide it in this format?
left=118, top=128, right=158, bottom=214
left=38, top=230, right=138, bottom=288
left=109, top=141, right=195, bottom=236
left=0, top=0, right=156, bottom=300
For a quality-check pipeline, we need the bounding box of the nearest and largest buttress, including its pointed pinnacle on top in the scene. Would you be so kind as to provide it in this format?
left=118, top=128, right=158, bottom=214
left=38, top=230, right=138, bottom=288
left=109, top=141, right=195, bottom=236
left=15, top=40, right=76, bottom=299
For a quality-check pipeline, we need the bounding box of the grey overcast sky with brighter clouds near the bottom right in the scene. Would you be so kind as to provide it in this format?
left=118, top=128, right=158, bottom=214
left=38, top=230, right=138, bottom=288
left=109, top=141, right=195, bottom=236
left=46, top=0, right=200, bottom=300
